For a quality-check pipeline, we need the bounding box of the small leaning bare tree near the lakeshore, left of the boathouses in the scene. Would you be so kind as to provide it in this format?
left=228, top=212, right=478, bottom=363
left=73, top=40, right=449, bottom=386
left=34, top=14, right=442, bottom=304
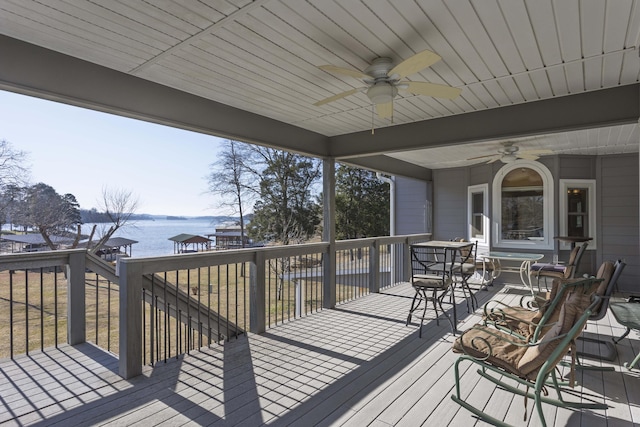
left=87, top=188, right=139, bottom=253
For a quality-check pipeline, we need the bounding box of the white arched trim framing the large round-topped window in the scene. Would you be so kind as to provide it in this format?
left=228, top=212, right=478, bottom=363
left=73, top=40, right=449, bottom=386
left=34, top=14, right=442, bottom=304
left=492, top=159, right=555, bottom=250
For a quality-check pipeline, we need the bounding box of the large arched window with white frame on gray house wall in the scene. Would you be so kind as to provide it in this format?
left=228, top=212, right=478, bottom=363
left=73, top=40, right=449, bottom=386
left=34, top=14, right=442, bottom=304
left=492, top=160, right=554, bottom=249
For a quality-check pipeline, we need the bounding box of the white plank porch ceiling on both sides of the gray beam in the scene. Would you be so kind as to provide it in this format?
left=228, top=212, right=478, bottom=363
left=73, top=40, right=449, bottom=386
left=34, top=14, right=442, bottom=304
left=0, top=0, right=640, bottom=167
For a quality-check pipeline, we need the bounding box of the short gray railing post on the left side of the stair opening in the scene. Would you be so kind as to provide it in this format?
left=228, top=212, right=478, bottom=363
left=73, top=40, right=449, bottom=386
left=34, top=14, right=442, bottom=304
left=67, top=251, right=87, bottom=345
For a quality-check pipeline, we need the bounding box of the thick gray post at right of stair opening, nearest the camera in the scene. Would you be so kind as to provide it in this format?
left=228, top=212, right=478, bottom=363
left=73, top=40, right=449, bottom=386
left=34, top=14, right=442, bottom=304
left=118, top=259, right=143, bottom=379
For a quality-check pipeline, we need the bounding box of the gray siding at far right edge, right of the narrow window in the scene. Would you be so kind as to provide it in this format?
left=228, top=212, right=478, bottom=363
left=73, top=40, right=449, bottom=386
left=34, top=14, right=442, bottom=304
left=597, top=154, right=640, bottom=294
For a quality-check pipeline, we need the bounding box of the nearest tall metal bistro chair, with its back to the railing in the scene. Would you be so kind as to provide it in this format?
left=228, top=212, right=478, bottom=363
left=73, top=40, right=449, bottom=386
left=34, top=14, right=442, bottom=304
left=406, top=246, right=456, bottom=337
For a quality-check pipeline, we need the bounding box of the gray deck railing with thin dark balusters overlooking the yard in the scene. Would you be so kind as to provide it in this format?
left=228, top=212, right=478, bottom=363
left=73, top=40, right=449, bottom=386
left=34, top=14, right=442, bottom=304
left=0, top=234, right=430, bottom=378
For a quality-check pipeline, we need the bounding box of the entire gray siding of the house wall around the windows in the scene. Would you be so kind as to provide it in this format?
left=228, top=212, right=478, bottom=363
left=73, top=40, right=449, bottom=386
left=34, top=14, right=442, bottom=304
left=396, top=154, right=640, bottom=294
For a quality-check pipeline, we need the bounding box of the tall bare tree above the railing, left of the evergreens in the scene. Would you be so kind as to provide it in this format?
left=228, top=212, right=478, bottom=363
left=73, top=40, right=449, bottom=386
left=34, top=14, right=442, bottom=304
left=207, top=140, right=258, bottom=248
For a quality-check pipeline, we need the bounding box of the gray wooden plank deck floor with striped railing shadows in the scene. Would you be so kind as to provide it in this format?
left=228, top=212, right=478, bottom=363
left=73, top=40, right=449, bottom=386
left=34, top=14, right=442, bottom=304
left=0, top=284, right=640, bottom=427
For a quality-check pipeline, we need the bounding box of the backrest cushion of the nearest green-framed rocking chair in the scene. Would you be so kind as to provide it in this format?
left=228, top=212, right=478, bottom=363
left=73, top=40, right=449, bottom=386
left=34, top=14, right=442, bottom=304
left=517, top=291, right=591, bottom=380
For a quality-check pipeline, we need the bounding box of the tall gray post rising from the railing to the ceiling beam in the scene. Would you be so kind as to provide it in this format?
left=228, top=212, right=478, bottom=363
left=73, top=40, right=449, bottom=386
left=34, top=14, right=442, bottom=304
left=322, top=158, right=336, bottom=308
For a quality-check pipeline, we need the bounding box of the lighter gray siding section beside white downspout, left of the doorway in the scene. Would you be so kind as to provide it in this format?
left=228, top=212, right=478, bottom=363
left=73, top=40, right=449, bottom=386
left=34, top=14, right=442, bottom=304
left=395, top=177, right=430, bottom=235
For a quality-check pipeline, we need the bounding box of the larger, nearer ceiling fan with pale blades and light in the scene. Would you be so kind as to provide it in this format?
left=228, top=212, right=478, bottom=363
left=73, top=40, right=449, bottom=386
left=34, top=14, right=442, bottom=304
left=313, top=50, right=462, bottom=119
